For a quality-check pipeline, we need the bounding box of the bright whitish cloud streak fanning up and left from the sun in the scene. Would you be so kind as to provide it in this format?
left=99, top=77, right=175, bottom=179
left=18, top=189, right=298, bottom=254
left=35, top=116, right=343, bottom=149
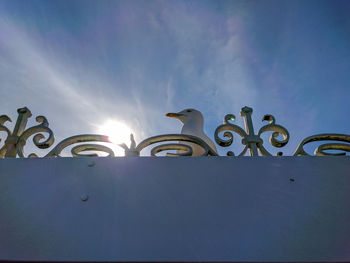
left=0, top=19, right=154, bottom=143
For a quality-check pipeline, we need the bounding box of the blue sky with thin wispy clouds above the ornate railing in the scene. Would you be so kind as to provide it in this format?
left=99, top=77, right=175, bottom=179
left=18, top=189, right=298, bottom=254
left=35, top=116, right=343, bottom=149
left=0, top=0, right=350, bottom=155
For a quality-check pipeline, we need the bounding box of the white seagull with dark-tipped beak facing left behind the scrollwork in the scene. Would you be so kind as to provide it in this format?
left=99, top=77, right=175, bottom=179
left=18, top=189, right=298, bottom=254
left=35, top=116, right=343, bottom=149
left=166, top=109, right=217, bottom=156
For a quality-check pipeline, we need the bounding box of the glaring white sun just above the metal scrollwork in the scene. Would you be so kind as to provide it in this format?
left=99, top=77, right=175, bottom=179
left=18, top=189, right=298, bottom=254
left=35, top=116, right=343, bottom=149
left=99, top=120, right=133, bottom=145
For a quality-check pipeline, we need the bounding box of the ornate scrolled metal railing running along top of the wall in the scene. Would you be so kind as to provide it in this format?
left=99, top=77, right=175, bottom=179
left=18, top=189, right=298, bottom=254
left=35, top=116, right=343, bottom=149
left=0, top=107, right=350, bottom=158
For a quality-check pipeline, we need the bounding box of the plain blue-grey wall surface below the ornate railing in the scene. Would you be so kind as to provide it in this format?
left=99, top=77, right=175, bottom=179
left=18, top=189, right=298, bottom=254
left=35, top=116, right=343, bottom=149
left=0, top=157, right=350, bottom=261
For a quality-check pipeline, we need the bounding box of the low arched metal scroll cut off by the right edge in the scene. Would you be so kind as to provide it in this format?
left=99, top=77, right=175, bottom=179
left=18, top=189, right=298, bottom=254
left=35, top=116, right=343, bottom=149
left=293, top=133, right=350, bottom=156
